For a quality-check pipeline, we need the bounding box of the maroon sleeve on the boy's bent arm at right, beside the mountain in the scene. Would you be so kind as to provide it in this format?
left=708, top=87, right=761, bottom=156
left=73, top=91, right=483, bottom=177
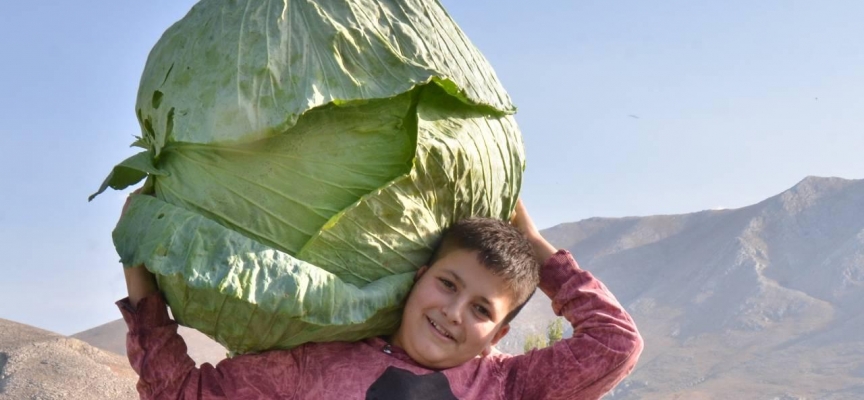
left=503, top=250, right=643, bottom=400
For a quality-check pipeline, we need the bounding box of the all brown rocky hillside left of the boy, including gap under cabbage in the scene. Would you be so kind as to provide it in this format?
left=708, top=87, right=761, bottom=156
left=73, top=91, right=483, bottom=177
left=0, top=310, right=226, bottom=400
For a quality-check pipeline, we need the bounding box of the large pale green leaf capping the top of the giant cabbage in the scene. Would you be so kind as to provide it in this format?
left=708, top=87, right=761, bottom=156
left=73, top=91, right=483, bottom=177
left=136, top=0, right=515, bottom=156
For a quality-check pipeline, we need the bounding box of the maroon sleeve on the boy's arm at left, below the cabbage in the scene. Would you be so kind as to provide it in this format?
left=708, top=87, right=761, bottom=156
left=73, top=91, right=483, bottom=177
left=117, top=293, right=302, bottom=400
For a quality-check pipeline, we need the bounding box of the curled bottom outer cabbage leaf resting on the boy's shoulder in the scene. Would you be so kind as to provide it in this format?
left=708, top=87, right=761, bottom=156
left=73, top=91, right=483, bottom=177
left=114, top=195, right=414, bottom=353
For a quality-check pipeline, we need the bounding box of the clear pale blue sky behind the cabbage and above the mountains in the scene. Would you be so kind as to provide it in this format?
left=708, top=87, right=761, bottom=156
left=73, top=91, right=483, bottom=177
left=0, top=0, right=864, bottom=335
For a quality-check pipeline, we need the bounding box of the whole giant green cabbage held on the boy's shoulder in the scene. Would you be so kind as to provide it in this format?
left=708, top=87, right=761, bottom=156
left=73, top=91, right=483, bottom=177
left=94, top=0, right=524, bottom=353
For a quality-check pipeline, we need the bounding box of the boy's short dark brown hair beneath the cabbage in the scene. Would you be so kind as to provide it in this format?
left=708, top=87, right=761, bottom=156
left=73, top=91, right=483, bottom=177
left=428, top=217, right=540, bottom=324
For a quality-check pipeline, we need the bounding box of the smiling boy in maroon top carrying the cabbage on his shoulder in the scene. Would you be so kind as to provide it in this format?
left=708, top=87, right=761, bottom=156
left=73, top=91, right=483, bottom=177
left=117, top=201, right=642, bottom=400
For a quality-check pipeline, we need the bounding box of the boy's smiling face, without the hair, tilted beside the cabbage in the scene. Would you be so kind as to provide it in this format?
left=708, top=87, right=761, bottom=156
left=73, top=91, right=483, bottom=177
left=393, top=249, right=513, bottom=369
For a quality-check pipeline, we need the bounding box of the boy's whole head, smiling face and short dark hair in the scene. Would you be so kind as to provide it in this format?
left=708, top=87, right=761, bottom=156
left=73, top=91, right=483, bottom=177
left=393, top=218, right=539, bottom=369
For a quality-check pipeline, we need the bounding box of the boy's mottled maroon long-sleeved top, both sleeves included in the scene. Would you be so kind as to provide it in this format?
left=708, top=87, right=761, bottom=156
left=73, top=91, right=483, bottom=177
left=117, top=250, right=642, bottom=400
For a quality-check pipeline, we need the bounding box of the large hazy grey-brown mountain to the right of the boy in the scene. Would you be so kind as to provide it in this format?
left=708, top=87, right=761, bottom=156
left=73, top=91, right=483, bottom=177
left=515, top=177, right=864, bottom=399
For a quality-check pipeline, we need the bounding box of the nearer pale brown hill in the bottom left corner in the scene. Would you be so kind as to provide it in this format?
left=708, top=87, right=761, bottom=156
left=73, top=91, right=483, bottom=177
left=0, top=319, right=138, bottom=400
